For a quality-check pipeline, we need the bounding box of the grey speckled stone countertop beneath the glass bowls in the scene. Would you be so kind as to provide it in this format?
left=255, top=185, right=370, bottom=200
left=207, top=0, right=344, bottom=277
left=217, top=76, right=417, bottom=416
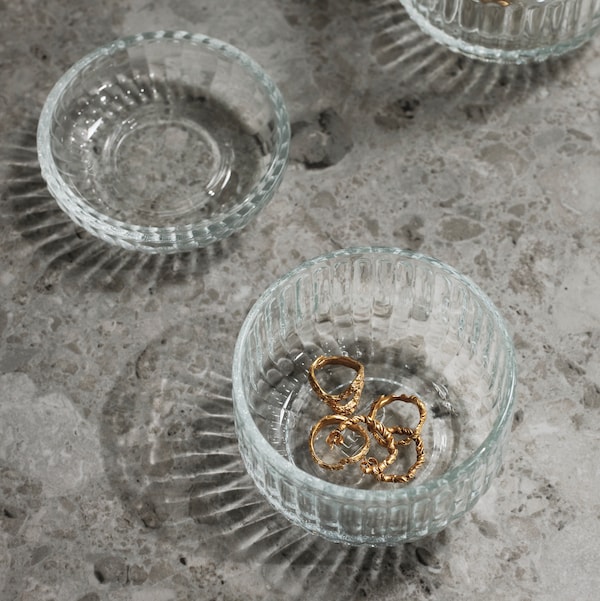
left=0, top=0, right=600, bottom=601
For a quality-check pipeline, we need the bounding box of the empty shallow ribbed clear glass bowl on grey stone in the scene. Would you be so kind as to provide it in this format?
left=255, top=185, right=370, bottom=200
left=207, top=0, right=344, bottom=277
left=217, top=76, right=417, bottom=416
left=37, top=31, right=290, bottom=253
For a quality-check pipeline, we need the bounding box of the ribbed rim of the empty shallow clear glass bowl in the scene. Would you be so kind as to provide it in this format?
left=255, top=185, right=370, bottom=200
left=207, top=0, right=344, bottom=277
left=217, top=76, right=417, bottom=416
left=37, top=30, right=291, bottom=252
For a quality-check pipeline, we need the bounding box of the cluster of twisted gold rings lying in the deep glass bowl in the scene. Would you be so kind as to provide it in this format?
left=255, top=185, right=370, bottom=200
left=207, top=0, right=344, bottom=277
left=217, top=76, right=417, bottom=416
left=308, top=355, right=427, bottom=483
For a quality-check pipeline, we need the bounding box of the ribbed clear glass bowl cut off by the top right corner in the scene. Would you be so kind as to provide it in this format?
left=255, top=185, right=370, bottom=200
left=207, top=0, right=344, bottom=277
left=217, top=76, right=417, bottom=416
left=400, top=0, right=600, bottom=63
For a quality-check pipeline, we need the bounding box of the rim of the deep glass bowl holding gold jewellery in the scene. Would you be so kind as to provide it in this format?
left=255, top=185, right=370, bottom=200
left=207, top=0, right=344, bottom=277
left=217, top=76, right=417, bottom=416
left=232, top=246, right=517, bottom=505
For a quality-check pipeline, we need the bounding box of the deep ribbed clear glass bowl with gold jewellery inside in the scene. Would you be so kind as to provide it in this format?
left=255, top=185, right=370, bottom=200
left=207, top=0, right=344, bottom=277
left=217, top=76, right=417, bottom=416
left=233, top=248, right=516, bottom=545
